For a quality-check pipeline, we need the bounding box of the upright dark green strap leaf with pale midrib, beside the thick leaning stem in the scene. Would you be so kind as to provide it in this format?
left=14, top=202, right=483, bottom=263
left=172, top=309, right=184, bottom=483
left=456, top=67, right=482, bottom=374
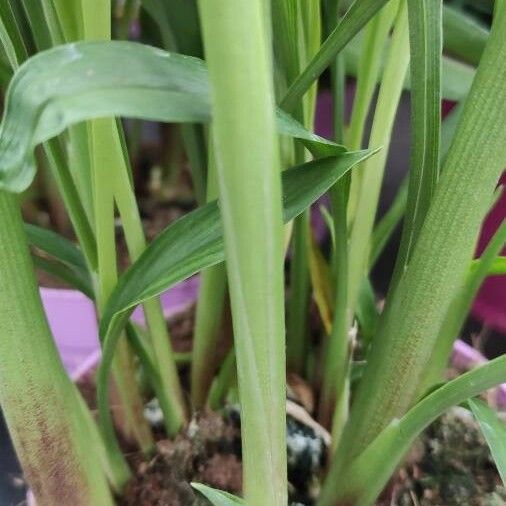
left=393, top=0, right=443, bottom=276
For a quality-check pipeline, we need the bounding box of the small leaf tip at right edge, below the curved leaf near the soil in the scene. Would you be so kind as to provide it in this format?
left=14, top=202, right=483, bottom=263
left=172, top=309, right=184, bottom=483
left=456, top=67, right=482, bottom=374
left=467, top=399, right=506, bottom=485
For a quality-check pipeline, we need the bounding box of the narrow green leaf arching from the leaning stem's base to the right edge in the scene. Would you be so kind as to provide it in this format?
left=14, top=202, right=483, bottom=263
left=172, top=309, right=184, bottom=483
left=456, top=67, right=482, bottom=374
left=318, top=355, right=506, bottom=506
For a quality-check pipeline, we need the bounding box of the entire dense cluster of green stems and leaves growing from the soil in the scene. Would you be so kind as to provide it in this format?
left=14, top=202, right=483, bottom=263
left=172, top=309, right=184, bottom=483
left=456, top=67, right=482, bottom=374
left=0, top=0, right=506, bottom=506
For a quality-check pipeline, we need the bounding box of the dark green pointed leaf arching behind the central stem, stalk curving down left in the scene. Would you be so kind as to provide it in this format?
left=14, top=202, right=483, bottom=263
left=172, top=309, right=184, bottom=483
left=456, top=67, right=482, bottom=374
left=97, top=151, right=374, bottom=462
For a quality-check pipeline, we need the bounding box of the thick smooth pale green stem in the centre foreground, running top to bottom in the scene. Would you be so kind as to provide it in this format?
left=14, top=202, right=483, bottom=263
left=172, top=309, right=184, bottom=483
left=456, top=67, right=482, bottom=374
left=200, top=0, right=287, bottom=506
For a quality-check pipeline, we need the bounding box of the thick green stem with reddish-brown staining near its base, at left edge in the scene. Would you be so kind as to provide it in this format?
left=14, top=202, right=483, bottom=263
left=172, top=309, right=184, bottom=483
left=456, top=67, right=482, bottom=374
left=0, top=192, right=113, bottom=506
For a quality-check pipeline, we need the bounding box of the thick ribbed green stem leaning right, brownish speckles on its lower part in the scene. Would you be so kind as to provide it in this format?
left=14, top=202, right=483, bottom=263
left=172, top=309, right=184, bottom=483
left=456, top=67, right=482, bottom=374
left=345, top=2, right=506, bottom=462
